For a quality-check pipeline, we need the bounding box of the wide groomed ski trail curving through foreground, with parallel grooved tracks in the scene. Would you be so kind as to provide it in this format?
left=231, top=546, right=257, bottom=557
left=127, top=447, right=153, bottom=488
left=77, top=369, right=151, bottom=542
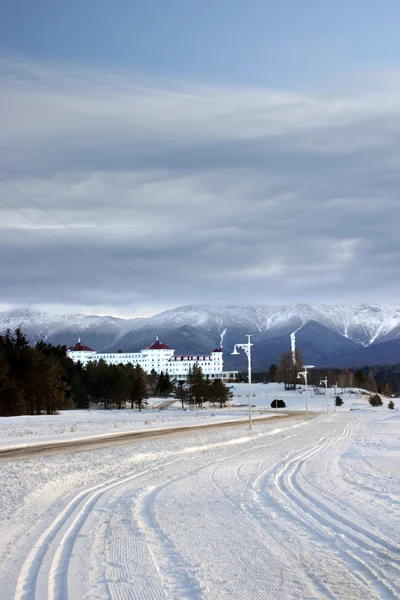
left=8, top=416, right=400, bottom=600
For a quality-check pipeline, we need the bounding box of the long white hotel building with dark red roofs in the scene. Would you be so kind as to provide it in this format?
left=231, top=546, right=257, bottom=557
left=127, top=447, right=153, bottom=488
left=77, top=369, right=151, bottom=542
left=67, top=336, right=238, bottom=381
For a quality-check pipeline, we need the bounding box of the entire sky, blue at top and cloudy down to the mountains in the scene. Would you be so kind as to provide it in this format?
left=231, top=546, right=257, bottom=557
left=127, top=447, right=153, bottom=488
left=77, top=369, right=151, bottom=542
left=0, top=0, right=400, bottom=316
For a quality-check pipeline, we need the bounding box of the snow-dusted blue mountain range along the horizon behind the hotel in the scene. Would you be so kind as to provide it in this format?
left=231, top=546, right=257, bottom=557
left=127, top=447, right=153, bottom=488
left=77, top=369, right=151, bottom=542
left=0, top=304, right=400, bottom=370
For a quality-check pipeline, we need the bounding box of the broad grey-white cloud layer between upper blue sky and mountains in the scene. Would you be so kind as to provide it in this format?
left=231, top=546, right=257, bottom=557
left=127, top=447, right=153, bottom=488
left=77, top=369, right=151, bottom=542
left=0, top=57, right=400, bottom=314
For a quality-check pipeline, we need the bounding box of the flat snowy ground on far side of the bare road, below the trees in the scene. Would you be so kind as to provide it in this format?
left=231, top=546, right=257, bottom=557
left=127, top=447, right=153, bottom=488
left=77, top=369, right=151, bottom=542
left=0, top=383, right=388, bottom=449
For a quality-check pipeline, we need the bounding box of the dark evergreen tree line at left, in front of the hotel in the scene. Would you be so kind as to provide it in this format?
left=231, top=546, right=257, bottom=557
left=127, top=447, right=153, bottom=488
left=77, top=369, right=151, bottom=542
left=0, top=329, right=230, bottom=416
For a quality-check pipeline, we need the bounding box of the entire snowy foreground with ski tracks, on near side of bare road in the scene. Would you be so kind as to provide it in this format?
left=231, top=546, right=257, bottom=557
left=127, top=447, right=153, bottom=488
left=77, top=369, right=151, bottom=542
left=0, top=411, right=400, bottom=600
